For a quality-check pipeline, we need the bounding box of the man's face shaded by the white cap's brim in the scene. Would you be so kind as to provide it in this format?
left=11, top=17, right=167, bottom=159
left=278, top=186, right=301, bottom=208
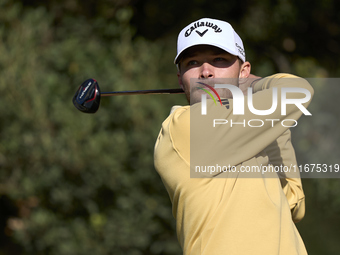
left=177, top=45, right=250, bottom=104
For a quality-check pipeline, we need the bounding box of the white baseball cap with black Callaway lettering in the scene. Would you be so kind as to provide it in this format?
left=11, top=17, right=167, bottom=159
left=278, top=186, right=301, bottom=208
left=174, top=18, right=246, bottom=64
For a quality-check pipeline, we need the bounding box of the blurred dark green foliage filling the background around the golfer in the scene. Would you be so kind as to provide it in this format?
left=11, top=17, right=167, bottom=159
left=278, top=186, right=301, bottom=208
left=0, top=0, right=340, bottom=255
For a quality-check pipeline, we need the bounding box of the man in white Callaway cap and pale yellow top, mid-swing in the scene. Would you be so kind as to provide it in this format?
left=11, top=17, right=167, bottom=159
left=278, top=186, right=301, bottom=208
left=154, top=18, right=313, bottom=255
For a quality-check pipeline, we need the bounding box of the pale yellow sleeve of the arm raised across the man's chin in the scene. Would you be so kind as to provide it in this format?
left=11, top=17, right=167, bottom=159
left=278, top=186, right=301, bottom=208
left=169, top=74, right=313, bottom=171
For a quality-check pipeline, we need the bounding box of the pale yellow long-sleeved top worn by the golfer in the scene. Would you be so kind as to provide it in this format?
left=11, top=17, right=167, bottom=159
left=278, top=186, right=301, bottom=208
left=154, top=74, right=313, bottom=255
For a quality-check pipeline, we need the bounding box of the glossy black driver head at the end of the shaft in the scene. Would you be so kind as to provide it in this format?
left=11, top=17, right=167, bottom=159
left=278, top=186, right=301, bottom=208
left=72, top=79, right=100, bottom=113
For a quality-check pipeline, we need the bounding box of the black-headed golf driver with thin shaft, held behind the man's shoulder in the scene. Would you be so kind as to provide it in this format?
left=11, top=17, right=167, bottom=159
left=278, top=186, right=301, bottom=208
left=72, top=79, right=184, bottom=113
